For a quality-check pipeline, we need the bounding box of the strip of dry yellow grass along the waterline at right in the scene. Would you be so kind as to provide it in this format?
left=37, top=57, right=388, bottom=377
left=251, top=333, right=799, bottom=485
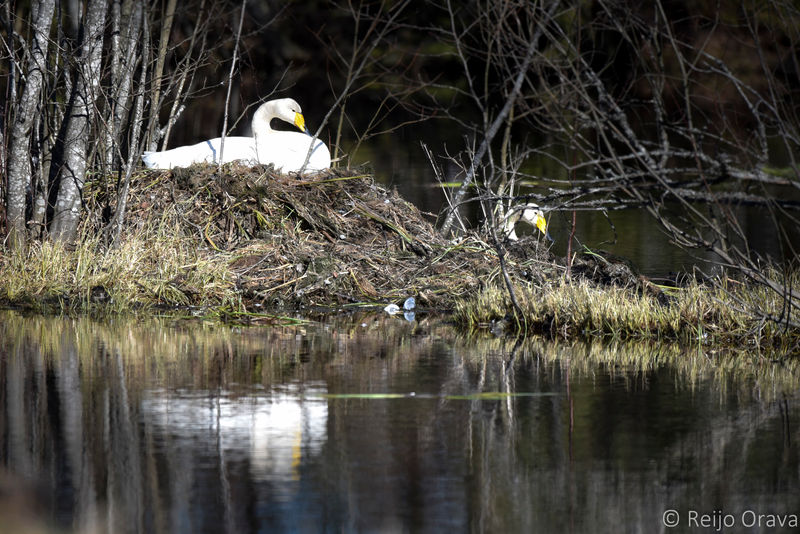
left=455, top=277, right=800, bottom=353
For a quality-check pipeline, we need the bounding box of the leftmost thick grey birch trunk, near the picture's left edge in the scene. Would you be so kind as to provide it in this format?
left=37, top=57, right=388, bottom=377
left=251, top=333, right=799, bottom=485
left=6, top=0, right=56, bottom=248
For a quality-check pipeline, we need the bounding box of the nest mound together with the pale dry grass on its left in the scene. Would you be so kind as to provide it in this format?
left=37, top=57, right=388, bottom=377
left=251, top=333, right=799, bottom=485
left=0, top=164, right=554, bottom=313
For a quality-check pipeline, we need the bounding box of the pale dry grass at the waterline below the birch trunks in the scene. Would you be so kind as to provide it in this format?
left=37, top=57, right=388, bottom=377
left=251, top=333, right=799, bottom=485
left=0, top=218, right=235, bottom=313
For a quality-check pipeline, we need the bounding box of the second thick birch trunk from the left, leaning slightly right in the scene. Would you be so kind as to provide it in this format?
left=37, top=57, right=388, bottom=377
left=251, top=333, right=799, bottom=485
left=50, top=0, right=107, bottom=242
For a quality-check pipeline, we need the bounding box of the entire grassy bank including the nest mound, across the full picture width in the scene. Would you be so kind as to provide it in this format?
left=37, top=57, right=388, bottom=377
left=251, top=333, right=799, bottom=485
left=0, top=164, right=797, bottom=351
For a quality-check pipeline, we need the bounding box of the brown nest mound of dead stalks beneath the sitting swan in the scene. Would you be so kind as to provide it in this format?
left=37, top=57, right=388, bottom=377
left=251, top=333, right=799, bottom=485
left=106, top=164, right=554, bottom=309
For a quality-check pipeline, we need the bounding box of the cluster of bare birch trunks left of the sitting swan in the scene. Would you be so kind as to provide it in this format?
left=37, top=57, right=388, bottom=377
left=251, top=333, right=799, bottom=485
left=0, top=0, right=245, bottom=246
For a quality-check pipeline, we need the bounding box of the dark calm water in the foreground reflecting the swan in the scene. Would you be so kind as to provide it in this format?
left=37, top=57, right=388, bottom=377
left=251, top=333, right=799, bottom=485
left=0, top=312, right=800, bottom=533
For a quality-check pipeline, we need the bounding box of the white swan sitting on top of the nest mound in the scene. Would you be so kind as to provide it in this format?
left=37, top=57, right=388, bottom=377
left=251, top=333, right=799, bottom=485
left=142, top=98, right=331, bottom=172
